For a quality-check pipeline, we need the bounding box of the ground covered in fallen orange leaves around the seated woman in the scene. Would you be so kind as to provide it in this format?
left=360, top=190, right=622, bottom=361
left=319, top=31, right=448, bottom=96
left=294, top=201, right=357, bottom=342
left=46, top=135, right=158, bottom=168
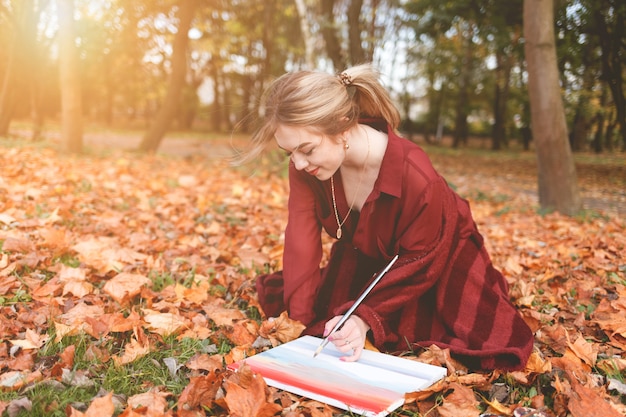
left=0, top=141, right=626, bottom=417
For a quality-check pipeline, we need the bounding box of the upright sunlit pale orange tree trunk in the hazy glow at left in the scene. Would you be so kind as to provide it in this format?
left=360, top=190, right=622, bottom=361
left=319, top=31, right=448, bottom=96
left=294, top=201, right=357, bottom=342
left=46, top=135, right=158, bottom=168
left=57, top=0, right=83, bottom=153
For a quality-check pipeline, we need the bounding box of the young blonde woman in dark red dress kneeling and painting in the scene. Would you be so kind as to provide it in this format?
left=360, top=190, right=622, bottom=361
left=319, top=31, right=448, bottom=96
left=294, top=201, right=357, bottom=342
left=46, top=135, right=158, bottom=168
left=247, top=65, right=533, bottom=369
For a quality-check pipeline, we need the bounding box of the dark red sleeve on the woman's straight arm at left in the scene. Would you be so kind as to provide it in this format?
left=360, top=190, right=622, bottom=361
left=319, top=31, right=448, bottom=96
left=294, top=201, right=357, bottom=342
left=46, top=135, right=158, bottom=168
left=283, top=164, right=322, bottom=325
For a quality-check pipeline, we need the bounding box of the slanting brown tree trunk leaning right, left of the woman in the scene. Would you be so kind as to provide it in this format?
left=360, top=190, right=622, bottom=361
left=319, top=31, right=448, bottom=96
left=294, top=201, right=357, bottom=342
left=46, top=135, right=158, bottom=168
left=139, top=0, right=198, bottom=152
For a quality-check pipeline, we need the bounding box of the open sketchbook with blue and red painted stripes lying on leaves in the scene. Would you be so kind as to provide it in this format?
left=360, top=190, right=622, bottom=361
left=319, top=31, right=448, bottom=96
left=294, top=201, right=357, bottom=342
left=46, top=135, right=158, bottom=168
left=229, top=336, right=447, bottom=417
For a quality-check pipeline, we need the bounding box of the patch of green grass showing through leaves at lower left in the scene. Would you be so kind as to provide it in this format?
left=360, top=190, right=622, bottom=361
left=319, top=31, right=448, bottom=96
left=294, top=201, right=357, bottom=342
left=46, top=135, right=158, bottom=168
left=0, top=331, right=224, bottom=417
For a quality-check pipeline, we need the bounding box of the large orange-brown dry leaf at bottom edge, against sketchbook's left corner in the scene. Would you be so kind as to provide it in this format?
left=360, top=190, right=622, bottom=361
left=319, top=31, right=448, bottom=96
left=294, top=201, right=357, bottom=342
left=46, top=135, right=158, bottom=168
left=224, top=363, right=282, bottom=417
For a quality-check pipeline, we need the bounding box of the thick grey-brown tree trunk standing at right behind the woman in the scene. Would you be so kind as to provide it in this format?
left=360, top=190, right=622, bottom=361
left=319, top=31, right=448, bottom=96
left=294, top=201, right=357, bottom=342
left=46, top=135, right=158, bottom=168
left=524, top=0, right=581, bottom=215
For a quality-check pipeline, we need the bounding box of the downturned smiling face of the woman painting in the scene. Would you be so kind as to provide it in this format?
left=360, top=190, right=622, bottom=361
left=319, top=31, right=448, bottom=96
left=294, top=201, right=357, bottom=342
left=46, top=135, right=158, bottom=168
left=275, top=125, right=346, bottom=181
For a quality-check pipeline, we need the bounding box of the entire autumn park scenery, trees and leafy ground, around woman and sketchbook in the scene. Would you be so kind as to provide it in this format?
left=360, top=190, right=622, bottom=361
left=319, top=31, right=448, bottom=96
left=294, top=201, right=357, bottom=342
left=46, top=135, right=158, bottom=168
left=0, top=0, right=626, bottom=417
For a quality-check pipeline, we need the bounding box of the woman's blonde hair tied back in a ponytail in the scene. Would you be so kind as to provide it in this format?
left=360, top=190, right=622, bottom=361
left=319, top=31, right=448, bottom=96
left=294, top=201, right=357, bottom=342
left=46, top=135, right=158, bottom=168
left=235, top=64, right=400, bottom=163
